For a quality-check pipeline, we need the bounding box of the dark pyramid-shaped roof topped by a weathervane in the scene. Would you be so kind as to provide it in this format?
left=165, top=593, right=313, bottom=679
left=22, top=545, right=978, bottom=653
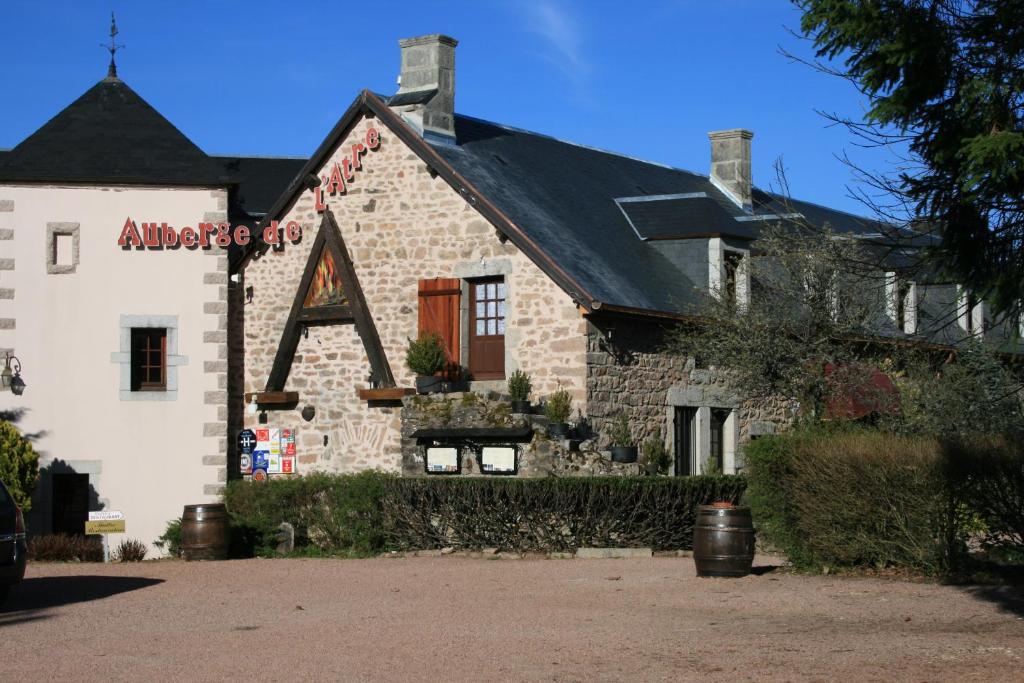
left=0, top=78, right=229, bottom=185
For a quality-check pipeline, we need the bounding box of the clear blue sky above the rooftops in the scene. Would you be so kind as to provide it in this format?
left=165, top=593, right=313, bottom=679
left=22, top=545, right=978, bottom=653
left=0, top=0, right=884, bottom=213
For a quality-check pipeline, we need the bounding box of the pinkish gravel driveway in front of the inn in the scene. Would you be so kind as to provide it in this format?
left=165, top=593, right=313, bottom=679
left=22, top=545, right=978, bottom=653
left=0, top=557, right=1024, bottom=682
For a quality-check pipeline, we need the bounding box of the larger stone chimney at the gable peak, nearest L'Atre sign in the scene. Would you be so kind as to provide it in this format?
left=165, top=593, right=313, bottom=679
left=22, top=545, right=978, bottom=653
left=391, top=34, right=459, bottom=142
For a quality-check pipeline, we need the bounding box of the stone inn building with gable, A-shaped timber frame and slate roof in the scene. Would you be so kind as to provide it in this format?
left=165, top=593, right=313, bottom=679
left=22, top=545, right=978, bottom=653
left=231, top=35, right=1015, bottom=481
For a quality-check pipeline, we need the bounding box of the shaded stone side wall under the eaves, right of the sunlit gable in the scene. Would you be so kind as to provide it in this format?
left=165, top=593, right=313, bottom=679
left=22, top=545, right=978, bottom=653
left=587, top=318, right=792, bottom=462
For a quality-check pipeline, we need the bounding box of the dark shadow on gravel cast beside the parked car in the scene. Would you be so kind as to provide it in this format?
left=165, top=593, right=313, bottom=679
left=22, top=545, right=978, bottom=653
left=0, top=577, right=164, bottom=627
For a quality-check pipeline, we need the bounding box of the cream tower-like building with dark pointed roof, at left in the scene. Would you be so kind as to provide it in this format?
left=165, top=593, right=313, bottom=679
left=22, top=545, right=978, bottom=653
left=0, top=57, right=302, bottom=544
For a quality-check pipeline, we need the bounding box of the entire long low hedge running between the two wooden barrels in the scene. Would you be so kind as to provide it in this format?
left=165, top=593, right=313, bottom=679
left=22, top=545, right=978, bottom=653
left=224, top=472, right=746, bottom=554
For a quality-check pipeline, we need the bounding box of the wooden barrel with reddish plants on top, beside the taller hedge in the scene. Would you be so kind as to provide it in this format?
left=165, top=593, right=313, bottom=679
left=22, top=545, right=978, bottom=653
left=693, top=505, right=754, bottom=578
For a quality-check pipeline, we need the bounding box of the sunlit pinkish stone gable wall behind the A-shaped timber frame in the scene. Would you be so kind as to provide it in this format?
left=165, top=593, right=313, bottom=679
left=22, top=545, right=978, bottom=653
left=243, top=113, right=587, bottom=473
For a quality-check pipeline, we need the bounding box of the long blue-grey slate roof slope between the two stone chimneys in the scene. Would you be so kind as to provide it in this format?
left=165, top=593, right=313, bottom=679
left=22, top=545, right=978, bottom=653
left=431, top=115, right=909, bottom=314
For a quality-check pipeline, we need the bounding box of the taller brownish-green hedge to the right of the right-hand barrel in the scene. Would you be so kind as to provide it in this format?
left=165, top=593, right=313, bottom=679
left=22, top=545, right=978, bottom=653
left=745, top=427, right=1024, bottom=573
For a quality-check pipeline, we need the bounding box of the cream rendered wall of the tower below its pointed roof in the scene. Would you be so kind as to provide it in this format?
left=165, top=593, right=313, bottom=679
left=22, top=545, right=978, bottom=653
left=0, top=185, right=227, bottom=557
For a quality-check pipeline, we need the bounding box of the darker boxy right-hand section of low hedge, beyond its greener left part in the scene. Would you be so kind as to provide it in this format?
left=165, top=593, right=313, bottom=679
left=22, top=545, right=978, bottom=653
left=382, top=476, right=746, bottom=552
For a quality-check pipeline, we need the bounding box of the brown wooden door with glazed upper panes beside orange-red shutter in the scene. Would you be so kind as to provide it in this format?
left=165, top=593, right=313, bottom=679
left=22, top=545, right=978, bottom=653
left=469, top=278, right=506, bottom=380
